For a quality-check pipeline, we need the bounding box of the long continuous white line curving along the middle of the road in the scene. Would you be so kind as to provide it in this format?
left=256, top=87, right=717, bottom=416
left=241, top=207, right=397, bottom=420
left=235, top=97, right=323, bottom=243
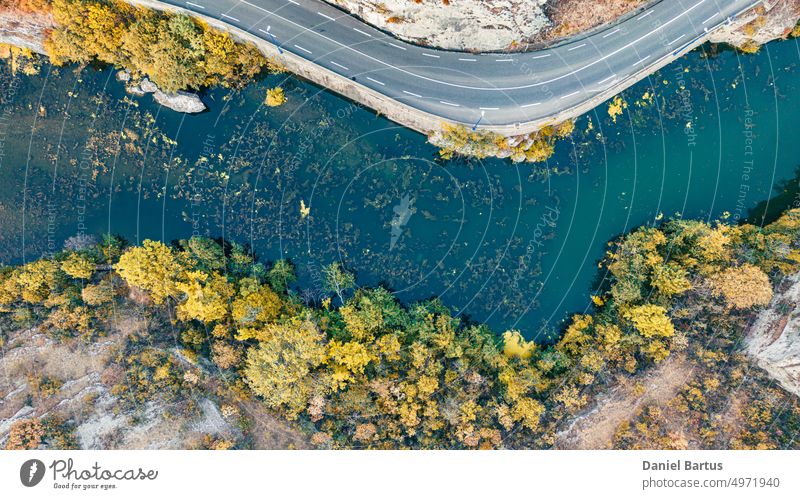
left=239, top=0, right=706, bottom=92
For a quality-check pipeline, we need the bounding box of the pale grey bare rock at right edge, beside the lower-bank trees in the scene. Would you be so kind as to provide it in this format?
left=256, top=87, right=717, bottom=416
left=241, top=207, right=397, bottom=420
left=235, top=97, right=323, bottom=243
left=746, top=274, right=800, bottom=396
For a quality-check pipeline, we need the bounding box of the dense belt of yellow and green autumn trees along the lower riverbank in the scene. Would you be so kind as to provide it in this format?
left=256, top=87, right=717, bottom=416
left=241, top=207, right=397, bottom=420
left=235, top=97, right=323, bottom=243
left=0, top=210, right=800, bottom=448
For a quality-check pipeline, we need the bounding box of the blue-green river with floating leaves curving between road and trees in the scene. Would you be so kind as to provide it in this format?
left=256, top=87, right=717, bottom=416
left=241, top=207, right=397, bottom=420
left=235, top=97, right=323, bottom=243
left=0, top=41, right=800, bottom=340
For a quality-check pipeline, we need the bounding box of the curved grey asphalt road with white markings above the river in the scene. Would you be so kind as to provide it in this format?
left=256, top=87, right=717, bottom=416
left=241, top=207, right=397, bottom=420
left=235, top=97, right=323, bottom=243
left=163, top=0, right=761, bottom=125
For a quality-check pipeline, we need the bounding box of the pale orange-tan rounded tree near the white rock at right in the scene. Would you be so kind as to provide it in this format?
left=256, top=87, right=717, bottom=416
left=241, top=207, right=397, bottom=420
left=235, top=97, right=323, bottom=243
left=708, top=263, right=772, bottom=309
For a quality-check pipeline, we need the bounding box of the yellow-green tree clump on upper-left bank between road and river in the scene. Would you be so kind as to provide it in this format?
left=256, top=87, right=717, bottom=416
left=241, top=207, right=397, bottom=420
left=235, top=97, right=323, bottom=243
left=7, top=0, right=282, bottom=93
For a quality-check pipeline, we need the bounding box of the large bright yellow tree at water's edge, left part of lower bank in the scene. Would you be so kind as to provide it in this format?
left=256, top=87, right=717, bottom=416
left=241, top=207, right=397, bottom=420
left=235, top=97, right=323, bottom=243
left=114, top=239, right=183, bottom=305
